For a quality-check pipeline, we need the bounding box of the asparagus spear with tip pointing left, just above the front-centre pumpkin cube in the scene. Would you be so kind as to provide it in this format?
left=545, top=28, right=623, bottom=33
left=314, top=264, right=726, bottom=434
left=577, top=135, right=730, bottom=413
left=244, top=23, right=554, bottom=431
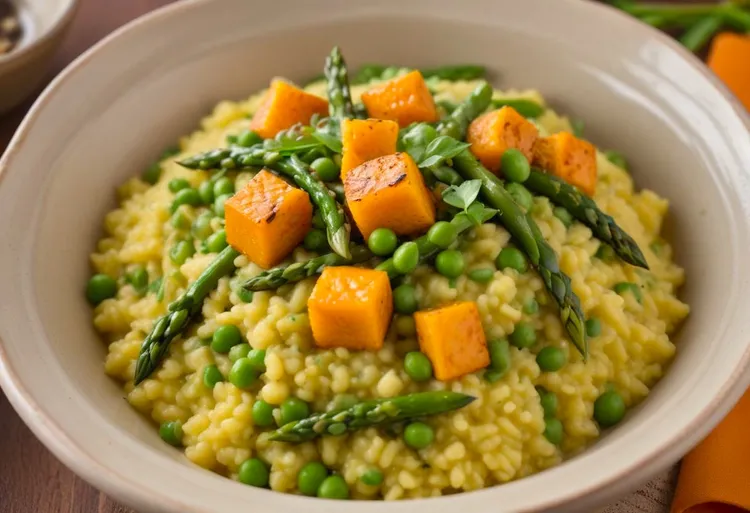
left=241, top=245, right=372, bottom=292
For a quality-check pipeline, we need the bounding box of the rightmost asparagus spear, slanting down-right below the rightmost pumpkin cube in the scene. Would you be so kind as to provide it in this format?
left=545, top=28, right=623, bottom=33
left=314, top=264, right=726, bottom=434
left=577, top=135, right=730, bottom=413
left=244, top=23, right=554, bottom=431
left=524, top=169, right=648, bottom=269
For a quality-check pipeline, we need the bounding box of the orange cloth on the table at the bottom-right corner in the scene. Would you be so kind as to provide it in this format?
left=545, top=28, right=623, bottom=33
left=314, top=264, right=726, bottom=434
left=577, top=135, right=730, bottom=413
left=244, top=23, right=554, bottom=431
left=672, top=390, right=750, bottom=513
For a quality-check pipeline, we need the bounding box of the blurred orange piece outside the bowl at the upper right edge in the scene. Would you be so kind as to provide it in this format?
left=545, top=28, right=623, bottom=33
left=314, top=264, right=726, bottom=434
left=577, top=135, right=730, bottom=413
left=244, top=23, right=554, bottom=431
left=708, top=32, right=750, bottom=109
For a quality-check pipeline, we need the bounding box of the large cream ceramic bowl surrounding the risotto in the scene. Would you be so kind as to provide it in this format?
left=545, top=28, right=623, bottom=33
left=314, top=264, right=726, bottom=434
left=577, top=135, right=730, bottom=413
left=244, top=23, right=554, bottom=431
left=0, top=0, right=750, bottom=513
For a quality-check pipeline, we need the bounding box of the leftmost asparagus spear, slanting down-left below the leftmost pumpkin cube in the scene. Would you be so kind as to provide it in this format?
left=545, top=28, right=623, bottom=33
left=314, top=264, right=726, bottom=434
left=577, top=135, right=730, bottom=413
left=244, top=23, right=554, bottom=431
left=134, top=246, right=239, bottom=385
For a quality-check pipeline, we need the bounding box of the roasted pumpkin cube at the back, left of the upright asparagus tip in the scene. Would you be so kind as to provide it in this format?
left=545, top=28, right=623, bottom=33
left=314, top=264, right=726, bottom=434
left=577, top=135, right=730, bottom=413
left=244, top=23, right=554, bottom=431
left=250, top=78, right=328, bottom=139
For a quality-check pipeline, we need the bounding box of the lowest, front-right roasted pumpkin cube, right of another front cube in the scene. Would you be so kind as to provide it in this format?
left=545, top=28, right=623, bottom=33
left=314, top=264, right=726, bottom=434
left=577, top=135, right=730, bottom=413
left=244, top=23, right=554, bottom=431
left=414, top=301, right=490, bottom=381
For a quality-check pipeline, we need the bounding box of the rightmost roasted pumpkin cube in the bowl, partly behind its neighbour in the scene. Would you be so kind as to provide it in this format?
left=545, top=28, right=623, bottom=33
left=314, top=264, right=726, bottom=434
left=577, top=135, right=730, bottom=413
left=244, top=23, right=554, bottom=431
left=534, top=132, right=597, bottom=196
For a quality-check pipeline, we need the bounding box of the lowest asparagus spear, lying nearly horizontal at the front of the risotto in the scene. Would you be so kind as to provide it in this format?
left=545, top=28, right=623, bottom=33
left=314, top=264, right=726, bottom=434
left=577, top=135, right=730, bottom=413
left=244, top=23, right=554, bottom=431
left=269, top=391, right=476, bottom=443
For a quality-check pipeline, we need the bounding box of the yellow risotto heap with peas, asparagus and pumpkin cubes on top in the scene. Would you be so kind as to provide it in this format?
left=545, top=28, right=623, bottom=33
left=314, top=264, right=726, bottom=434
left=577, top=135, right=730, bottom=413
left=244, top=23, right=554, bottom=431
left=87, top=50, right=689, bottom=500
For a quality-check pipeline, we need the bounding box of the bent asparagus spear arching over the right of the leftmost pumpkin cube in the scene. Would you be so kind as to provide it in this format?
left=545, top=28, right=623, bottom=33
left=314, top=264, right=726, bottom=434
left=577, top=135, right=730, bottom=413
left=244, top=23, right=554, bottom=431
left=179, top=147, right=351, bottom=259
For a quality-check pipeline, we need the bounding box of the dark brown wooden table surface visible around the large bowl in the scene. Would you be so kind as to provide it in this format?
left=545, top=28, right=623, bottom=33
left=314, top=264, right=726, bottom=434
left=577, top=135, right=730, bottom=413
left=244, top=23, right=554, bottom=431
left=0, top=0, right=692, bottom=513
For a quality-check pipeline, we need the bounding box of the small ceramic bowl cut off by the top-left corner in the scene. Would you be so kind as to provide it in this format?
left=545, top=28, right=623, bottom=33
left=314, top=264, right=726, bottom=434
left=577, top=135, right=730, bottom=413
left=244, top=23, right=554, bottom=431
left=0, top=0, right=78, bottom=114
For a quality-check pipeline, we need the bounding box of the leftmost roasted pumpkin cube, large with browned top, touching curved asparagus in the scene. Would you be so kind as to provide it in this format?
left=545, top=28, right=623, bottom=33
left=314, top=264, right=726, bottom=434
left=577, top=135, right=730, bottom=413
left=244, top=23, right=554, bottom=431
left=224, top=170, right=312, bottom=269
